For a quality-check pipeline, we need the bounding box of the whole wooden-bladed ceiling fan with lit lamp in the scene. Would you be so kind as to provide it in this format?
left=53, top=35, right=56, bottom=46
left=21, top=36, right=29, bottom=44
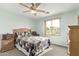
left=19, top=3, right=49, bottom=15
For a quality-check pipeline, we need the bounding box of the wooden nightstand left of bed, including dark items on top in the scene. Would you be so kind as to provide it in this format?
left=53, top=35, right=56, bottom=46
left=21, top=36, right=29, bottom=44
left=1, top=34, right=14, bottom=52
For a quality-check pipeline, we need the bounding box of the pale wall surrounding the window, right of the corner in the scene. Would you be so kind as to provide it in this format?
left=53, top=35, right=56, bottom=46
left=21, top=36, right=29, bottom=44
left=36, top=10, right=78, bottom=46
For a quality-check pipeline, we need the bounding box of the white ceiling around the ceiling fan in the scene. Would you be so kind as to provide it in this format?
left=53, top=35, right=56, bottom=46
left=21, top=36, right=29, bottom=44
left=0, top=3, right=79, bottom=19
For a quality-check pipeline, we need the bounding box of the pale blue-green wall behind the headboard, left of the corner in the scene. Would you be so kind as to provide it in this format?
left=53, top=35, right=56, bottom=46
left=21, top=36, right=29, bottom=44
left=0, top=10, right=35, bottom=47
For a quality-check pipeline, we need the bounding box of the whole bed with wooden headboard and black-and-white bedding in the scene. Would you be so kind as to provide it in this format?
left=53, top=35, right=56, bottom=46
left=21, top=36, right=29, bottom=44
left=13, top=28, right=50, bottom=56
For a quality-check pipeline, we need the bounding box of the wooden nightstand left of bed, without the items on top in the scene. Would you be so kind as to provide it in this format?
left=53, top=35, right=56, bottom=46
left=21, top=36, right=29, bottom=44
left=1, top=34, right=14, bottom=52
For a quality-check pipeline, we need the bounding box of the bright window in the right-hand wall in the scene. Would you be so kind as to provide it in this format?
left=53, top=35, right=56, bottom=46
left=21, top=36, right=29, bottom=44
left=45, top=19, right=60, bottom=36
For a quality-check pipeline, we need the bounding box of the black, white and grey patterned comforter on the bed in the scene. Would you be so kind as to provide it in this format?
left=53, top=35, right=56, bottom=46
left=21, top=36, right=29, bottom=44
left=15, top=32, right=50, bottom=56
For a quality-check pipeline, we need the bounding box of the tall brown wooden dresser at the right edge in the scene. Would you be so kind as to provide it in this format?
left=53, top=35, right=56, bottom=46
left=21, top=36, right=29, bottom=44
left=68, top=26, right=79, bottom=56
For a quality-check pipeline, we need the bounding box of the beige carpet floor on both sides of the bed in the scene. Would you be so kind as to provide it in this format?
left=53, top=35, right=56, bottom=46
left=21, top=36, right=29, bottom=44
left=0, top=45, right=67, bottom=56
